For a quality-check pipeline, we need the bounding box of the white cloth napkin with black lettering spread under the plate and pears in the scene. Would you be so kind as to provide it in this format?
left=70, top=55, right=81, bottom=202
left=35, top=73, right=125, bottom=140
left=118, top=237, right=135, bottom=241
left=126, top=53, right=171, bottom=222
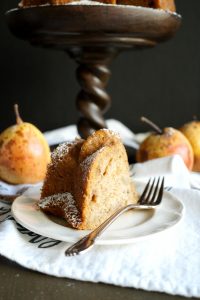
left=0, top=122, right=200, bottom=297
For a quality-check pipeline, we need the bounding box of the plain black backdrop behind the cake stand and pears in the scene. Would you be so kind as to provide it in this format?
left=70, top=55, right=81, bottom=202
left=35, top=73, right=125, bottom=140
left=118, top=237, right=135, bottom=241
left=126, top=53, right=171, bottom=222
left=0, top=0, right=200, bottom=132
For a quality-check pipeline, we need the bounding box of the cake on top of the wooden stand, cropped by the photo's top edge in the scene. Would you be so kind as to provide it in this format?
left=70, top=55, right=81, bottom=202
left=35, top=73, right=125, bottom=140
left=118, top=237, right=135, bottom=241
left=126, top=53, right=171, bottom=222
left=19, top=0, right=176, bottom=12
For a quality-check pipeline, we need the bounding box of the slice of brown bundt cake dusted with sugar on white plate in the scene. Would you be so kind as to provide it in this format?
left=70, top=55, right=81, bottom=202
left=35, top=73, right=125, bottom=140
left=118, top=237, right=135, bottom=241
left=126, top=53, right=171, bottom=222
left=39, top=129, right=138, bottom=229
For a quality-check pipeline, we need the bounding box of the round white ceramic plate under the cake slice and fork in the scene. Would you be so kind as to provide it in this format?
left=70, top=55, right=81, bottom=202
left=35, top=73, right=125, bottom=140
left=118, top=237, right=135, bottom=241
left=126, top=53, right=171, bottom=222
left=12, top=183, right=184, bottom=245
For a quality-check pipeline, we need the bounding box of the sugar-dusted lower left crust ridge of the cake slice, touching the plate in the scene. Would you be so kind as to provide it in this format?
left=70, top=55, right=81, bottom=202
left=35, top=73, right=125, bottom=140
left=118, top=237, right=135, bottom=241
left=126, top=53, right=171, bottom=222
left=38, top=192, right=81, bottom=228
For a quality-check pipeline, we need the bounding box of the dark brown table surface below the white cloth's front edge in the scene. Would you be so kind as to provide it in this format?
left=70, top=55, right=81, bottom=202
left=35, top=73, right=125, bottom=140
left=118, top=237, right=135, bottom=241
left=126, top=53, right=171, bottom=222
left=0, top=256, right=192, bottom=300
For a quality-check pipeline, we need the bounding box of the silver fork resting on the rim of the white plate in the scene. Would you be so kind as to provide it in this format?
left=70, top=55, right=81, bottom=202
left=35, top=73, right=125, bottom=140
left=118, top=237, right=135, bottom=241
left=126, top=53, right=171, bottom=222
left=65, top=177, right=164, bottom=256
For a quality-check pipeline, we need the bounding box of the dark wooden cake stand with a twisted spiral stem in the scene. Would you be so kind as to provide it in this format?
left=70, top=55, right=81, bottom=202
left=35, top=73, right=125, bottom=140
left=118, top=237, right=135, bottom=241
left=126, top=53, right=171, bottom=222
left=6, top=4, right=181, bottom=138
